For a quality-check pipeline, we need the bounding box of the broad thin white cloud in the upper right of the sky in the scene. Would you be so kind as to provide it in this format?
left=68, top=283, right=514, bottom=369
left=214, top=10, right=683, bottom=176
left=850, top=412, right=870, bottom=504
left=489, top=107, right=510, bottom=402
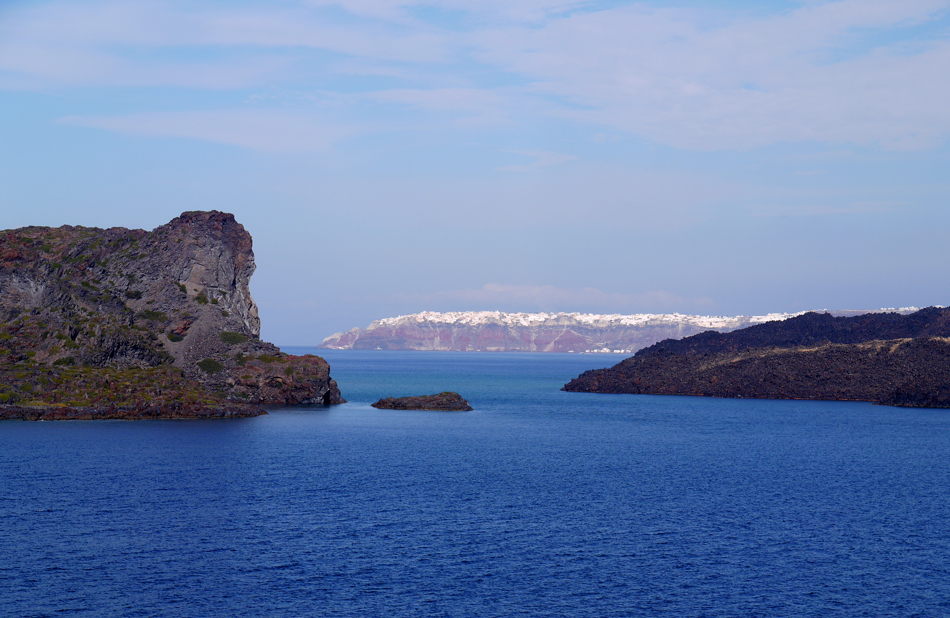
left=476, top=0, right=950, bottom=150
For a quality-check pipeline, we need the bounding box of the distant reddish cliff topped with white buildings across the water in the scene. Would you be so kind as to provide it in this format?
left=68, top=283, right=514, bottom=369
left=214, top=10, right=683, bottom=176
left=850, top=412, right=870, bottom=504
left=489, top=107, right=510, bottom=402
left=320, top=311, right=804, bottom=354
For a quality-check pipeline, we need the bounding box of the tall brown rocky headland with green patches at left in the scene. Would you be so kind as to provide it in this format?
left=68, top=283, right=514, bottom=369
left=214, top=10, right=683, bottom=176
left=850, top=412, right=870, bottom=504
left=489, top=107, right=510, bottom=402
left=0, top=211, right=343, bottom=417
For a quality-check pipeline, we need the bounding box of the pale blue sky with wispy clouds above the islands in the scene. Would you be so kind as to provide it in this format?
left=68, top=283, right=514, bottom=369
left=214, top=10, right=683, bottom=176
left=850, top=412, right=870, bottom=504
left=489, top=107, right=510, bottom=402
left=0, top=0, right=950, bottom=345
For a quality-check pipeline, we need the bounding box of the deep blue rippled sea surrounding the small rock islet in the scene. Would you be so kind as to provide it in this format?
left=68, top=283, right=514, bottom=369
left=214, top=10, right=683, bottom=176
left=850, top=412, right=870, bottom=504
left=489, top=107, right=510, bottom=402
left=0, top=350, right=950, bottom=617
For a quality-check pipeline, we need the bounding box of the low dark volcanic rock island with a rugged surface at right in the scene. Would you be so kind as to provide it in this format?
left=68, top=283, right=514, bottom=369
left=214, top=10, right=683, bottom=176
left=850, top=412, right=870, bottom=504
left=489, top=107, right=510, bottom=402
left=563, top=307, right=950, bottom=407
